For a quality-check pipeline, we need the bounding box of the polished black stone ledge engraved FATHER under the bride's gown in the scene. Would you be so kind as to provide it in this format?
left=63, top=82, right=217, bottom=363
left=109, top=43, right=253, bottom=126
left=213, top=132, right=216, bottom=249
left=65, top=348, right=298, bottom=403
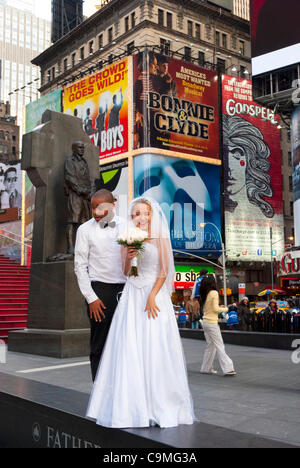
left=0, top=373, right=293, bottom=449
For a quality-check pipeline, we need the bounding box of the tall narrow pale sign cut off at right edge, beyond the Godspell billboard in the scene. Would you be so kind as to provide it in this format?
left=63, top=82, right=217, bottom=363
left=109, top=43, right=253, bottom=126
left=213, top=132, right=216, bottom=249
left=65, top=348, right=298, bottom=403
left=291, top=106, right=300, bottom=246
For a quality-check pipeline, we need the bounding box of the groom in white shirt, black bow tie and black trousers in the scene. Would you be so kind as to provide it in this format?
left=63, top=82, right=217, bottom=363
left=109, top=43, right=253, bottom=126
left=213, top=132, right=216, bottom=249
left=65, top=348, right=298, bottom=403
left=75, top=190, right=127, bottom=381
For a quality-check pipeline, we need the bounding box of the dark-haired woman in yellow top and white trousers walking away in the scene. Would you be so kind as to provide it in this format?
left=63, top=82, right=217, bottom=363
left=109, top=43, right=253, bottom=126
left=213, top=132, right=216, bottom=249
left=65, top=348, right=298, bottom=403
left=200, top=275, right=236, bottom=376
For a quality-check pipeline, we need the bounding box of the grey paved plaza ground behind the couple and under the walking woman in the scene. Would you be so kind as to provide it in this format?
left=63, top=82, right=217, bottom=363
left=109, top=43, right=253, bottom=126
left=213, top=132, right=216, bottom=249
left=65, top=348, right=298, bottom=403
left=0, top=340, right=300, bottom=446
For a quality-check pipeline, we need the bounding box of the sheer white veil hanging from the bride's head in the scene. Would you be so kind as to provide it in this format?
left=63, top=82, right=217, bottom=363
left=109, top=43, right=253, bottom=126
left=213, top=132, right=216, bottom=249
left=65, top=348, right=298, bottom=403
left=129, top=196, right=175, bottom=295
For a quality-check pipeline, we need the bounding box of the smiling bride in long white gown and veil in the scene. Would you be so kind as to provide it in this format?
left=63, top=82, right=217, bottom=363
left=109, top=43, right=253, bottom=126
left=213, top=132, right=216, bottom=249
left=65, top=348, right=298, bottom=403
left=87, top=198, right=194, bottom=428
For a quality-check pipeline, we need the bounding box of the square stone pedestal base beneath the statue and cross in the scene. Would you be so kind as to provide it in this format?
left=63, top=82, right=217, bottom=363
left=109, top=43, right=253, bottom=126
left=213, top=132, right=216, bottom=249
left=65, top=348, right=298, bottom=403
left=8, top=262, right=90, bottom=359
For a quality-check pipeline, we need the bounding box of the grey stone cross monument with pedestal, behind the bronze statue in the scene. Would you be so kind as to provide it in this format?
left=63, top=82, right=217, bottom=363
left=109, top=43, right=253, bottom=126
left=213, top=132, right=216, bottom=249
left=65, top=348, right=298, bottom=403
left=8, top=111, right=99, bottom=358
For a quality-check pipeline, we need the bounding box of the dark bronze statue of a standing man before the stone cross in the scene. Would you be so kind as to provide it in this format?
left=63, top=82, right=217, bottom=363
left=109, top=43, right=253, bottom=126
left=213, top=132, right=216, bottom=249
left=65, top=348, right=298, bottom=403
left=65, top=141, right=92, bottom=255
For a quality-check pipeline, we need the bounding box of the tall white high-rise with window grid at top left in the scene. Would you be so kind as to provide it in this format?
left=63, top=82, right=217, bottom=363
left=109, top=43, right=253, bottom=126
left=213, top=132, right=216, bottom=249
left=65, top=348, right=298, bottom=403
left=0, top=0, right=50, bottom=133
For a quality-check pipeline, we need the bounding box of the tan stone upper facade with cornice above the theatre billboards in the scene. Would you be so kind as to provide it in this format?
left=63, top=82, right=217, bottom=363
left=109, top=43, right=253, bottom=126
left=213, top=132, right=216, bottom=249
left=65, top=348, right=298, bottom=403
left=33, top=0, right=251, bottom=94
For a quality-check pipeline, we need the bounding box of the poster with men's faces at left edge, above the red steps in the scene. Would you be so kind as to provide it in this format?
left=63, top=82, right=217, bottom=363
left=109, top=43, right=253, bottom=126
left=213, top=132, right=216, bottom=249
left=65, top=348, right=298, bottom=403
left=0, top=159, right=22, bottom=223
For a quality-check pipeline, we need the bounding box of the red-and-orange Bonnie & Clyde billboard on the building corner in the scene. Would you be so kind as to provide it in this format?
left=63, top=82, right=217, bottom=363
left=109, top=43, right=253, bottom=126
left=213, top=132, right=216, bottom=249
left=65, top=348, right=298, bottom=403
left=133, top=51, right=219, bottom=159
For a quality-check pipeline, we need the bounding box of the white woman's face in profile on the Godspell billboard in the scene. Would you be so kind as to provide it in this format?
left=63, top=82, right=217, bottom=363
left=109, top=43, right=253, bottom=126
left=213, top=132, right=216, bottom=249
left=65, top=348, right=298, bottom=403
left=227, top=146, right=247, bottom=195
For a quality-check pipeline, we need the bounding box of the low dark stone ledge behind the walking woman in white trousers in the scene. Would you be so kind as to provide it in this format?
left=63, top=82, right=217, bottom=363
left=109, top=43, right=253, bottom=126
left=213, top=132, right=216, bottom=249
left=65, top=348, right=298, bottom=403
left=180, top=328, right=300, bottom=351
